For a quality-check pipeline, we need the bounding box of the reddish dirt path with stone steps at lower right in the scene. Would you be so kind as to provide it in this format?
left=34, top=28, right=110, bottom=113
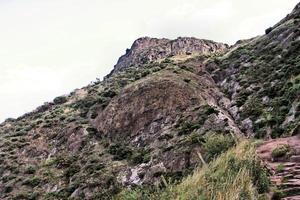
left=257, top=136, right=300, bottom=200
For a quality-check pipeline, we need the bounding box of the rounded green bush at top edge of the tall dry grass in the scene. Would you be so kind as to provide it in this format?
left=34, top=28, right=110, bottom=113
left=203, top=134, right=235, bottom=161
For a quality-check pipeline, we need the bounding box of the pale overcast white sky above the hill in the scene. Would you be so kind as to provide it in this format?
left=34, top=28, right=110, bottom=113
left=0, top=0, right=298, bottom=122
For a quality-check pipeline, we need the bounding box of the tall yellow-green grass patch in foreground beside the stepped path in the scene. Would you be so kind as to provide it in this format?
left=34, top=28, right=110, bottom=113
left=116, top=141, right=269, bottom=200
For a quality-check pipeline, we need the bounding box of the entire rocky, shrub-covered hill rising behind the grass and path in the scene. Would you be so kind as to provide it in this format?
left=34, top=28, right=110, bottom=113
left=0, top=1, right=300, bottom=199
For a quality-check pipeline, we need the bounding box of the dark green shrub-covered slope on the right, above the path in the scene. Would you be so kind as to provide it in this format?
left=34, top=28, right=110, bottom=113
left=206, top=1, right=300, bottom=138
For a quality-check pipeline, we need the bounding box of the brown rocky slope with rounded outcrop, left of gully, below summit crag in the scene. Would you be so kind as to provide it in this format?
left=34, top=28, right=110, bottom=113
left=0, top=39, right=232, bottom=199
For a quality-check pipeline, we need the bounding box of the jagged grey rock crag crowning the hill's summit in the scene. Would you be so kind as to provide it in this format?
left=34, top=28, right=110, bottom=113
left=114, top=37, right=228, bottom=71
